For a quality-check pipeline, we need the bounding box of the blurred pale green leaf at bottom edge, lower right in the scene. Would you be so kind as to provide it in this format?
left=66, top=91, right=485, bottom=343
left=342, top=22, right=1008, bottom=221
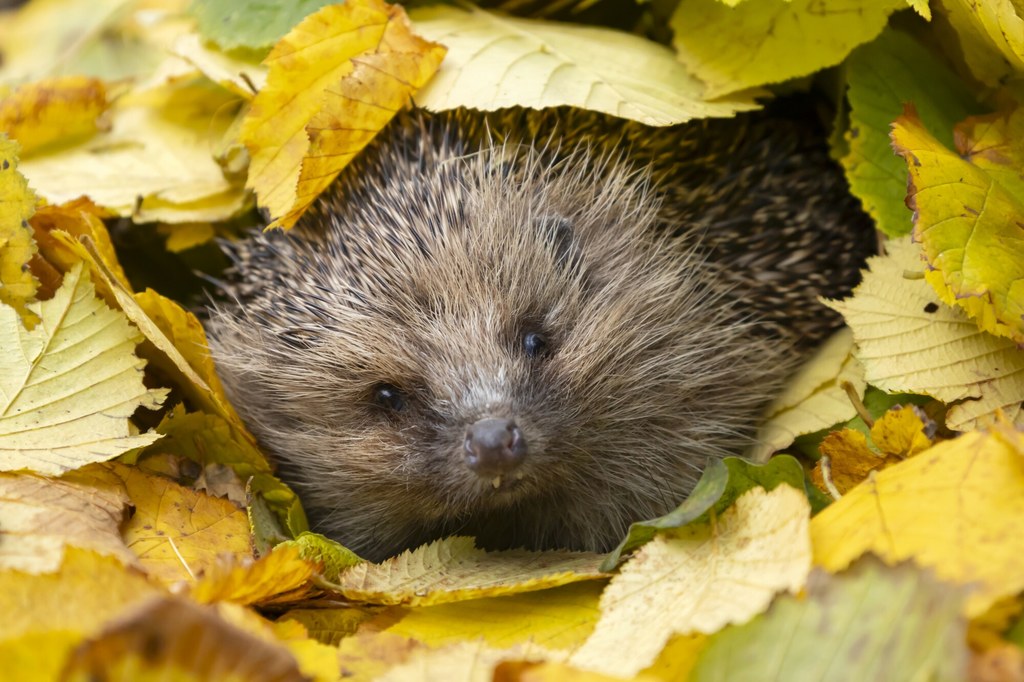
left=689, top=559, right=968, bottom=682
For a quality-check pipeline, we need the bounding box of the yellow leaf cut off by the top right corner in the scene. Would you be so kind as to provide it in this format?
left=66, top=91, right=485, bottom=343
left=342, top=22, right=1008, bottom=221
left=942, top=0, right=1024, bottom=87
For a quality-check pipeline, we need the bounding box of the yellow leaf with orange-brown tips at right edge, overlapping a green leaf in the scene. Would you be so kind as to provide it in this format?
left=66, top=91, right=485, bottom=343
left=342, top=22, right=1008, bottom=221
left=892, top=108, right=1024, bottom=344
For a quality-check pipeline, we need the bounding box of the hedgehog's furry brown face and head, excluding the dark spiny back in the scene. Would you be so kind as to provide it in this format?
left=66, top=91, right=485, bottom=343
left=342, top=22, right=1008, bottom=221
left=203, top=114, right=782, bottom=559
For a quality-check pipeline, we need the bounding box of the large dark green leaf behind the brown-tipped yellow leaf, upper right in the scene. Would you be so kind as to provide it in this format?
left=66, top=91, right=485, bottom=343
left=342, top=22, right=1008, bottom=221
left=842, top=30, right=977, bottom=237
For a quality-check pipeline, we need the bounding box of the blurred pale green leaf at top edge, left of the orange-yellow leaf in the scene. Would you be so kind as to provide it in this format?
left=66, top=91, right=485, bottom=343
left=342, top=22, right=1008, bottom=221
left=188, top=0, right=335, bottom=50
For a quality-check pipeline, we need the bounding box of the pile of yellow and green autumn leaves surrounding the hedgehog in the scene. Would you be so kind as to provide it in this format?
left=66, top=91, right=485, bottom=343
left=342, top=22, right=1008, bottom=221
left=0, top=0, right=1024, bottom=681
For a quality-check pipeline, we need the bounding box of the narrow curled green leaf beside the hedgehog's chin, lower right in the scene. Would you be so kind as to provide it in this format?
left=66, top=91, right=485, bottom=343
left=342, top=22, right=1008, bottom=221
left=601, top=455, right=807, bottom=570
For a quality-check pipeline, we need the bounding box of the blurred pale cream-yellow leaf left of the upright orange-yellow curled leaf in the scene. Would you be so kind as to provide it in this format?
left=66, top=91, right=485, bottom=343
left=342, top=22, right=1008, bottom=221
left=22, top=81, right=244, bottom=222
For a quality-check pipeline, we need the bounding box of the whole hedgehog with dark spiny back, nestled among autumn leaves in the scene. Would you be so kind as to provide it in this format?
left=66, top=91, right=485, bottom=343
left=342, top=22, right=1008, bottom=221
left=207, top=104, right=873, bottom=560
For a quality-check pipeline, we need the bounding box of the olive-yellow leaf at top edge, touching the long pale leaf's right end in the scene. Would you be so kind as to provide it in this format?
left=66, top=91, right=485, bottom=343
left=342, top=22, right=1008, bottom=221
left=671, top=0, right=906, bottom=99
